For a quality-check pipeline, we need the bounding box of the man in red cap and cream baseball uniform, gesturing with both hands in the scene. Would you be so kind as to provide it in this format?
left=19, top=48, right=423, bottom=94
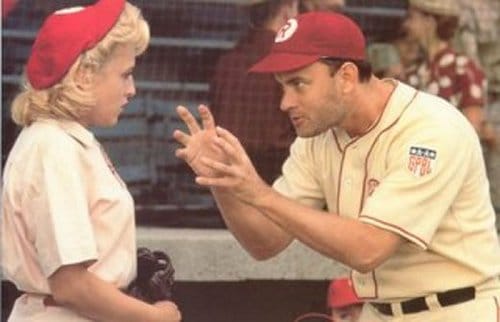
left=174, top=13, right=500, bottom=322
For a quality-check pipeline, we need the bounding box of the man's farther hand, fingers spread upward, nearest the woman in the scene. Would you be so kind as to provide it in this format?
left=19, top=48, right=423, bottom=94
left=174, top=105, right=224, bottom=177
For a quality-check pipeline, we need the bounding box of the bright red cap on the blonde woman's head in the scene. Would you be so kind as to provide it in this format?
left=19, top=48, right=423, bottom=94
left=27, top=0, right=125, bottom=89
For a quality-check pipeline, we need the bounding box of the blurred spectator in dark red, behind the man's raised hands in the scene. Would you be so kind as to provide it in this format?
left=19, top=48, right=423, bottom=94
left=209, top=0, right=298, bottom=183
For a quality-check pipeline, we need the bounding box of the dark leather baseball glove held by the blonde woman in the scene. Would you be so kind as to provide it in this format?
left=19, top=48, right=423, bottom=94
left=126, top=247, right=175, bottom=304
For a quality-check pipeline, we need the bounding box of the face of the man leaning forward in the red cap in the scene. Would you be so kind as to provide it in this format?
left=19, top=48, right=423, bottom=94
left=276, top=62, right=349, bottom=137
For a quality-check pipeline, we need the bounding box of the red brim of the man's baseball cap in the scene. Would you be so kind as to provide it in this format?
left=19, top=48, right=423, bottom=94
left=248, top=53, right=321, bottom=73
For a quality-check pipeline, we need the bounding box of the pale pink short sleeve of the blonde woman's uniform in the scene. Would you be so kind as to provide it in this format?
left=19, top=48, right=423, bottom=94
left=24, top=134, right=97, bottom=277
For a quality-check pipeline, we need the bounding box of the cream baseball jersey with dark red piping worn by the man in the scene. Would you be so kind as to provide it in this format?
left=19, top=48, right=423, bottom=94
left=273, top=80, right=500, bottom=300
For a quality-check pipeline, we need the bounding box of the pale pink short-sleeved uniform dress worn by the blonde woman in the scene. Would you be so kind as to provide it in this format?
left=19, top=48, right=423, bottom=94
left=1, top=120, right=136, bottom=322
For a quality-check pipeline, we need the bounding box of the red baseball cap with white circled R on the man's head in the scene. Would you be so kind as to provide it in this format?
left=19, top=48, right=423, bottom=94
left=250, top=12, right=366, bottom=73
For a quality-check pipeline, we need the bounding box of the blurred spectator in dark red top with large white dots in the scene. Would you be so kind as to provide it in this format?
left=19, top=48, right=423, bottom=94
left=404, top=0, right=495, bottom=145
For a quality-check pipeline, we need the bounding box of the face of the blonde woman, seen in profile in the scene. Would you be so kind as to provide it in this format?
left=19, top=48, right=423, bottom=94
left=84, top=45, right=136, bottom=127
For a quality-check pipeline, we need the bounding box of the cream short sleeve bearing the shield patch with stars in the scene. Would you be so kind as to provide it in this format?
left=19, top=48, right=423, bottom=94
left=360, top=117, right=474, bottom=249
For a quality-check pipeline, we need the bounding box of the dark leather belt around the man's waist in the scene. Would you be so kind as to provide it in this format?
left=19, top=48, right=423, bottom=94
left=370, top=287, right=476, bottom=315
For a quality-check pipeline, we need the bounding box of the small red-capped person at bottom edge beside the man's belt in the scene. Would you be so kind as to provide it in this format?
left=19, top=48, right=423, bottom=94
left=327, top=277, right=363, bottom=322
